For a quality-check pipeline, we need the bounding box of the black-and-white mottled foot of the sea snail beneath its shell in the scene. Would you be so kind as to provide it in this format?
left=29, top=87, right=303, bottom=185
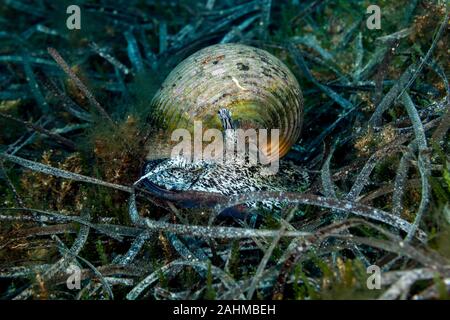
left=138, top=157, right=309, bottom=218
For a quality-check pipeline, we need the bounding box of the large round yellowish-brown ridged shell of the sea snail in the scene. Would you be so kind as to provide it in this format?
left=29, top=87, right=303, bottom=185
left=148, top=44, right=303, bottom=160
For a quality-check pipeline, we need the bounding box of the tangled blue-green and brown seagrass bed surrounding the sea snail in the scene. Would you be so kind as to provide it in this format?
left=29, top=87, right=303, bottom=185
left=0, top=0, right=450, bottom=300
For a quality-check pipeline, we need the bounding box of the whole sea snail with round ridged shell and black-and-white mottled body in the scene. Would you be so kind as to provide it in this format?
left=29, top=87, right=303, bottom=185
left=143, top=44, right=307, bottom=208
